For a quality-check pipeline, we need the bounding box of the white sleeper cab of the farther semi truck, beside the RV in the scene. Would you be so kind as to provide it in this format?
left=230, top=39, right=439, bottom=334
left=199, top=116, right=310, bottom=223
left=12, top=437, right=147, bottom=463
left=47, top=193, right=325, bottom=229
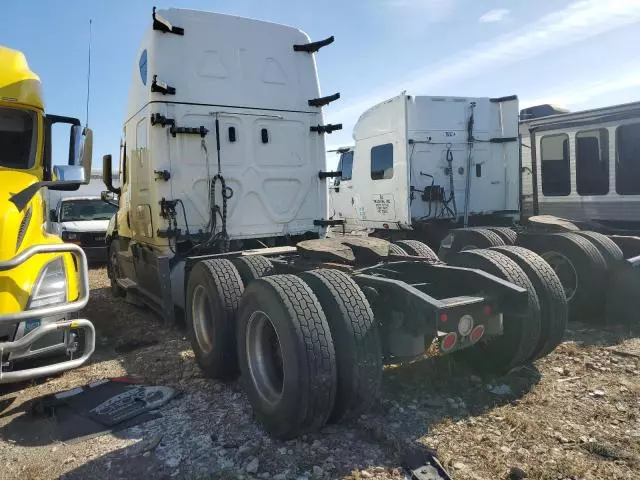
left=329, top=94, right=520, bottom=245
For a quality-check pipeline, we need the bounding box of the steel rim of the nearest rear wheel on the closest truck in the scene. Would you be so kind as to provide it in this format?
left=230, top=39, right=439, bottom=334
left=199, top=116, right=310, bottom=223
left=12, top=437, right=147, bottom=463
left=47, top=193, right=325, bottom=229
left=245, top=310, right=284, bottom=405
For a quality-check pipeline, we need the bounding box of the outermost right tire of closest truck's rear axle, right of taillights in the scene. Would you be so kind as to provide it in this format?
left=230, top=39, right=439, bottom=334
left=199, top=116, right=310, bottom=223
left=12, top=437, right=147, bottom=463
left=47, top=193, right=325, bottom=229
left=492, top=245, right=569, bottom=360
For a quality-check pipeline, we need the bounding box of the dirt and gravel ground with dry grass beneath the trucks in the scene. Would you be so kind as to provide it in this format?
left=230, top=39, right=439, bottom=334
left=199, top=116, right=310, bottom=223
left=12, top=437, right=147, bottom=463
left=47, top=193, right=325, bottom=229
left=0, top=268, right=640, bottom=480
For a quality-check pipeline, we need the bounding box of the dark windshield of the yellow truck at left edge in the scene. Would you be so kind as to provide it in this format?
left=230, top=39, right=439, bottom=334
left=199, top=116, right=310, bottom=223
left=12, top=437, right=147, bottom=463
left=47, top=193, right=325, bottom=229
left=0, top=107, right=36, bottom=170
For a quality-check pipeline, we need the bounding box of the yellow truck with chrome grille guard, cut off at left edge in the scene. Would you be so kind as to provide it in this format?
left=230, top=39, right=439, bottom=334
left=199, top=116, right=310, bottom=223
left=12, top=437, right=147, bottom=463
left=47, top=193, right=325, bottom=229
left=0, top=45, right=95, bottom=383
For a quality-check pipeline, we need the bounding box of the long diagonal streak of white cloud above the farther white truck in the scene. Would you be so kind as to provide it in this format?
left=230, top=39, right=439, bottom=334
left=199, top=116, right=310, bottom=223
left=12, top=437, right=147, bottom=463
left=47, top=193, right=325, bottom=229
left=328, top=0, right=640, bottom=128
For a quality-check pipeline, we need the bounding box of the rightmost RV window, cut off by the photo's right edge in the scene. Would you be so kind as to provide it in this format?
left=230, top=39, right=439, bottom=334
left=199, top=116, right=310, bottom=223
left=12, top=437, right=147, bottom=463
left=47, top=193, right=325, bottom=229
left=616, top=123, right=640, bottom=195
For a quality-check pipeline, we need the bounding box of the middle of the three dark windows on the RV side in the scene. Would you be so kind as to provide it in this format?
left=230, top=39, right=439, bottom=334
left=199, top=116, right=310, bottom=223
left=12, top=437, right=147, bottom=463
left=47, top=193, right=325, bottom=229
left=576, top=128, right=609, bottom=195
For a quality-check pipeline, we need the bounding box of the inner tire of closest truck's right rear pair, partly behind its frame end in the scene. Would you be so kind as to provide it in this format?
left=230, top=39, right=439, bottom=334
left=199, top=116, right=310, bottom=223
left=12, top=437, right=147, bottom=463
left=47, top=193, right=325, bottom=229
left=451, top=250, right=541, bottom=373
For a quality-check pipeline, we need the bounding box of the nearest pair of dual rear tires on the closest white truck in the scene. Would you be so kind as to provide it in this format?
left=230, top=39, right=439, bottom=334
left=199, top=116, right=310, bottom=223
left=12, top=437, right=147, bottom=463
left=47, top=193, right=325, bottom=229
left=237, top=270, right=382, bottom=439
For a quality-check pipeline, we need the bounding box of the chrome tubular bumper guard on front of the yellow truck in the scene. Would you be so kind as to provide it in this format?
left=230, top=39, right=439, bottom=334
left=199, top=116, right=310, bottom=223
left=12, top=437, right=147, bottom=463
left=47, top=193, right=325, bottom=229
left=0, top=243, right=96, bottom=384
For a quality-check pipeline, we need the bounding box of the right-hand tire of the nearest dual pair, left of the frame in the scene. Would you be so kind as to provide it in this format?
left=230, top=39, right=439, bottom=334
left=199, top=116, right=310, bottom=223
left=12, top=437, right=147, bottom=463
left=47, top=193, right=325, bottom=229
left=299, top=269, right=382, bottom=423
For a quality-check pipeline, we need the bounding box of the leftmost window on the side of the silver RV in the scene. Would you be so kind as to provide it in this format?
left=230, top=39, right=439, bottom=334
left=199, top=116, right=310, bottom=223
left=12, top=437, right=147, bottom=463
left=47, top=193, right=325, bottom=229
left=540, top=134, right=571, bottom=197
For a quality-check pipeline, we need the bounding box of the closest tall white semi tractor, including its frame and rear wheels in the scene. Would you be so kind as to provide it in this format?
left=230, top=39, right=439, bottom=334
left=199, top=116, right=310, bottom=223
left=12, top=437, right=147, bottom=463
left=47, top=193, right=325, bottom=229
left=103, top=9, right=566, bottom=438
